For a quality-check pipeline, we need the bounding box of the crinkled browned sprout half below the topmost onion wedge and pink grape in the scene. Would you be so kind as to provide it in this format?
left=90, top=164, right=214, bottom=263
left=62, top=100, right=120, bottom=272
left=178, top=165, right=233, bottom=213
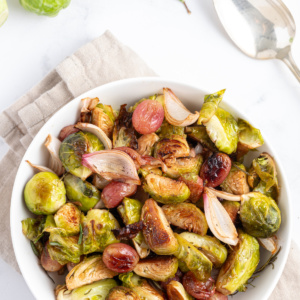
left=153, top=135, right=190, bottom=161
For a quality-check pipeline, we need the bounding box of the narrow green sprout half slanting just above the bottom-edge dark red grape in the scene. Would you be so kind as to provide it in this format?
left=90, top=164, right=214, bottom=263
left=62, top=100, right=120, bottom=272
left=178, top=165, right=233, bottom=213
left=174, top=233, right=212, bottom=281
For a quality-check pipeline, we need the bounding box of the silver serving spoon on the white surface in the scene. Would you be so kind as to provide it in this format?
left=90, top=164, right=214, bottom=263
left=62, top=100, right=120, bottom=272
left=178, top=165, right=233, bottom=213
left=214, top=0, right=300, bottom=82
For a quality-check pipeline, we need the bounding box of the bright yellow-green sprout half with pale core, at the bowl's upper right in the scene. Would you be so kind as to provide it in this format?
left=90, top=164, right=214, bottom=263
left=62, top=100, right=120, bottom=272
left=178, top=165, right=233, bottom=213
left=205, top=107, right=238, bottom=154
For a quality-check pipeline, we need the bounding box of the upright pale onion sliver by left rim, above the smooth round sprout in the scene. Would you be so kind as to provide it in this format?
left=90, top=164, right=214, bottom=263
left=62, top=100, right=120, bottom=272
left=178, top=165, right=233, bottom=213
left=45, top=134, right=65, bottom=176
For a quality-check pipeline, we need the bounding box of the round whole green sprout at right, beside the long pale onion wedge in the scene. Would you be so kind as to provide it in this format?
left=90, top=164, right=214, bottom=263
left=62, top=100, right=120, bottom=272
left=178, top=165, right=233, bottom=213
left=240, top=192, right=281, bottom=238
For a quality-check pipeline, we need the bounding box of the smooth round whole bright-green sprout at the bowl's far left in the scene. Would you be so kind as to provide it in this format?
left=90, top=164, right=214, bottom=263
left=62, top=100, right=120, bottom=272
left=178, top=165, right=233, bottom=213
left=24, top=172, right=66, bottom=215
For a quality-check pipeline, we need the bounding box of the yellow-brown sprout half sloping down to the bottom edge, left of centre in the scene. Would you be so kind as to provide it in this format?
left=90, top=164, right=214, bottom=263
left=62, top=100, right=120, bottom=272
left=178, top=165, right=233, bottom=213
left=119, top=272, right=164, bottom=300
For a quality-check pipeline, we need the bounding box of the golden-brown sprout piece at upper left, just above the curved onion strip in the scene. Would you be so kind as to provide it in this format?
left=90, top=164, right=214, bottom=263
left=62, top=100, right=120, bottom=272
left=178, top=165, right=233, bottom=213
left=92, top=103, right=115, bottom=138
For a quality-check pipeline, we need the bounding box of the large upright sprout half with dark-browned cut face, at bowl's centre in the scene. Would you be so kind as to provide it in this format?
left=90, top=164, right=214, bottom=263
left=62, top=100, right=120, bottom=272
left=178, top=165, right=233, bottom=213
left=141, top=199, right=178, bottom=255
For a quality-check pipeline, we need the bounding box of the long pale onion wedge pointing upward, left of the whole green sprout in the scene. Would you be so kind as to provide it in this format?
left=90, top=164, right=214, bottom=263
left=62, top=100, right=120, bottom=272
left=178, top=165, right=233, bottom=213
left=203, top=188, right=239, bottom=246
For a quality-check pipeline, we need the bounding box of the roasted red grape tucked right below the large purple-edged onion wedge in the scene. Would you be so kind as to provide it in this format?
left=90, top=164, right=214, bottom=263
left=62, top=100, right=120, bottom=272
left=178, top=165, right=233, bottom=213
left=101, top=181, right=136, bottom=208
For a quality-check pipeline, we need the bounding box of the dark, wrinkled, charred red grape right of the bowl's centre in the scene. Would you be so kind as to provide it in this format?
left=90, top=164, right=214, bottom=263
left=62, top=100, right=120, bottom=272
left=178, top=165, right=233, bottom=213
left=200, top=153, right=231, bottom=187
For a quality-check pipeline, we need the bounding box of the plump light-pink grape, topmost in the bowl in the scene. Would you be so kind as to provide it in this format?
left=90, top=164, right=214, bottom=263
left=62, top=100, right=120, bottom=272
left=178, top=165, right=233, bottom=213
left=132, top=100, right=165, bottom=134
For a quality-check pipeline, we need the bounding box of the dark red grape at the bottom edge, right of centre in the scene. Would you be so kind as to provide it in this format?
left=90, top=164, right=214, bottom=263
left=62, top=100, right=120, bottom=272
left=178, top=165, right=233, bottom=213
left=182, top=271, right=216, bottom=300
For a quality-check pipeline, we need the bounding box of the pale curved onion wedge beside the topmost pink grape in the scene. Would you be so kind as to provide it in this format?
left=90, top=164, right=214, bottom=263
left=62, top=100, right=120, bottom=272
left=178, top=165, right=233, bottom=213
left=163, top=88, right=199, bottom=127
